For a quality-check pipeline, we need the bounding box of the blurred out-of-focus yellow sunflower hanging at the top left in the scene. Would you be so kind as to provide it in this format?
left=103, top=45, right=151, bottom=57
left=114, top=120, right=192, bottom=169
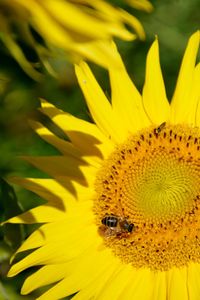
left=0, top=0, right=146, bottom=80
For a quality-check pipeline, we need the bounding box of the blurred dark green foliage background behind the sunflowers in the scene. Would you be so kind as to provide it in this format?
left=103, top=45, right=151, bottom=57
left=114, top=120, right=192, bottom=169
left=0, top=0, right=200, bottom=300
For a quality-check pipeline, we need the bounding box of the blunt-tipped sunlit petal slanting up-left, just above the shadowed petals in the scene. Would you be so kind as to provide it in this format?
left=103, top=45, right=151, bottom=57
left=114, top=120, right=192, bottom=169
left=76, top=62, right=127, bottom=143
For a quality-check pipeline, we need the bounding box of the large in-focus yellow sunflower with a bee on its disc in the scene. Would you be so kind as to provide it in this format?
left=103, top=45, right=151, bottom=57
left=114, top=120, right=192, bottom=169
left=5, top=32, right=200, bottom=300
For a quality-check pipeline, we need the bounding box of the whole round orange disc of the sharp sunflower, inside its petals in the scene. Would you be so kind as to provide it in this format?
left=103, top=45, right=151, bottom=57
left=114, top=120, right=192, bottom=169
left=93, top=124, right=200, bottom=271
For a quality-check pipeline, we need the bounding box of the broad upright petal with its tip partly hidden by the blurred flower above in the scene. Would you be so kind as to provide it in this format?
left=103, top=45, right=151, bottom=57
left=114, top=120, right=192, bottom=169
left=109, top=44, right=150, bottom=134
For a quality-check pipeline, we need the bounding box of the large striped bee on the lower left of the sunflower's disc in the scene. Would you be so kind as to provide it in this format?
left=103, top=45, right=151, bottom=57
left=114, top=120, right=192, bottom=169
left=101, top=215, right=134, bottom=237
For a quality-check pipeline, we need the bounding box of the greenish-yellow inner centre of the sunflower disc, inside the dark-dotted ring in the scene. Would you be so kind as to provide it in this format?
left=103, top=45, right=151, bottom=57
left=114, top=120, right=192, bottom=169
left=124, top=149, right=198, bottom=223
